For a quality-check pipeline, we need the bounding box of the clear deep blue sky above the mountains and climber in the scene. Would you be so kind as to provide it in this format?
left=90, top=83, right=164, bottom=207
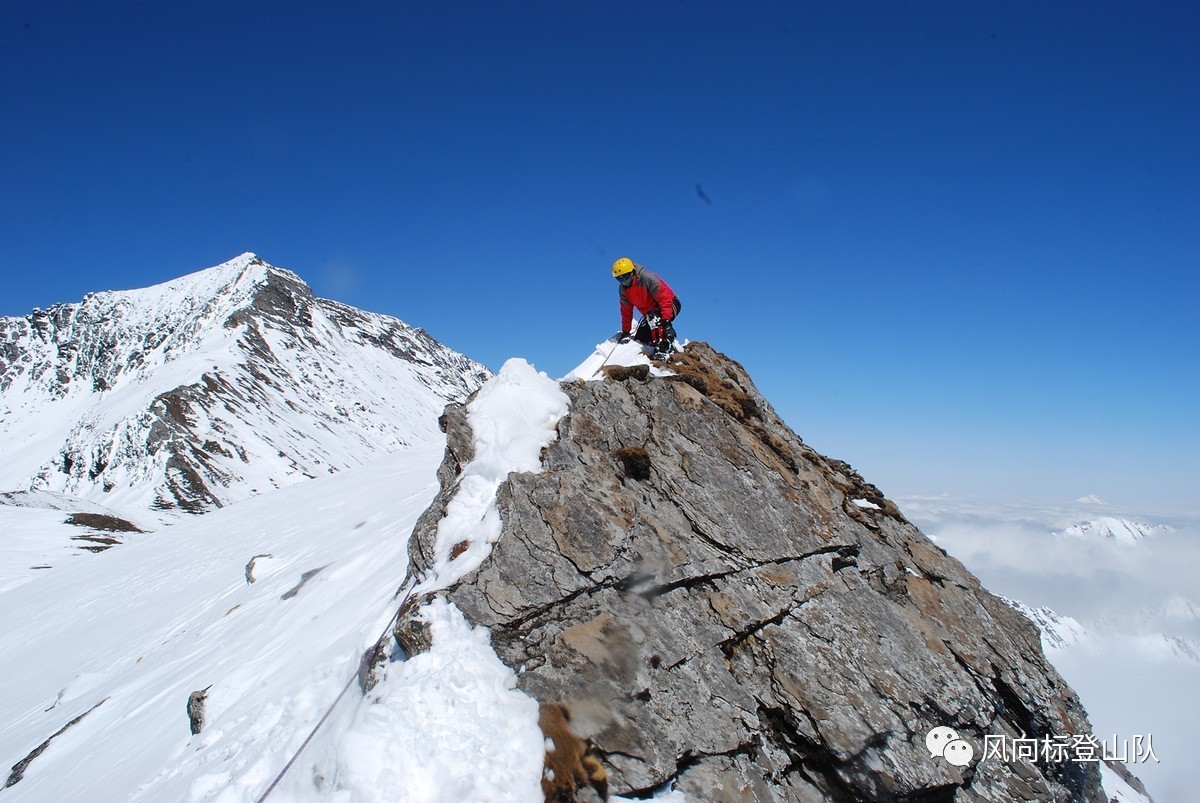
left=0, top=0, right=1200, bottom=504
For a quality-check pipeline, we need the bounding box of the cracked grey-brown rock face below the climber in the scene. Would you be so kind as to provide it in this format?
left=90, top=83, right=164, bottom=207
left=410, top=343, right=1104, bottom=803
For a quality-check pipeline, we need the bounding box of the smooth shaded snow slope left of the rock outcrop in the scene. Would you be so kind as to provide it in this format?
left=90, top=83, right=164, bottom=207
left=0, top=443, right=443, bottom=802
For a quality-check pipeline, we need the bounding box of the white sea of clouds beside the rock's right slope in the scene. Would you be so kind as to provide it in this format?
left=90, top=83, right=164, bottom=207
left=899, top=497, right=1200, bottom=801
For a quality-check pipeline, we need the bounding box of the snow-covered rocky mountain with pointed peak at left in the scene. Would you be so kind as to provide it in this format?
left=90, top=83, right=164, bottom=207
left=0, top=253, right=488, bottom=520
